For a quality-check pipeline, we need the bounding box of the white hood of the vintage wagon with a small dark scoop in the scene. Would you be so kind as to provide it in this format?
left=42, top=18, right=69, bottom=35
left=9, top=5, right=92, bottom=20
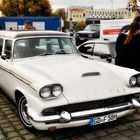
left=12, top=55, right=139, bottom=103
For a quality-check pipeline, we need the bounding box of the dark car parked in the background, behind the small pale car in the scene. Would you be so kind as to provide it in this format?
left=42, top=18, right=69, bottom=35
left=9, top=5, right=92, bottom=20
left=76, top=24, right=100, bottom=45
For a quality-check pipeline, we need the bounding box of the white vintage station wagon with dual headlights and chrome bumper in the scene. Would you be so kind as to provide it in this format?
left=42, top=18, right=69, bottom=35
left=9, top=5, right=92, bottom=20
left=0, top=31, right=140, bottom=130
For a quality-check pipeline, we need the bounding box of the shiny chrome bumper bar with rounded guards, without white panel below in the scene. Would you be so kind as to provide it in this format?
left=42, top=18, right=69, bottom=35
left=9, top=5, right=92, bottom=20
left=28, top=99, right=140, bottom=124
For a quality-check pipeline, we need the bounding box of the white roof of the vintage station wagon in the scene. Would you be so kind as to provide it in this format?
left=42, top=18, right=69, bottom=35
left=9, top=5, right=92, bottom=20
left=0, top=30, right=69, bottom=39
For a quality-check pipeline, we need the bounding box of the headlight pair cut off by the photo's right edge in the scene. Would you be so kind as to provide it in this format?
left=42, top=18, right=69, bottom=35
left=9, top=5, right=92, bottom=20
left=129, top=74, right=140, bottom=87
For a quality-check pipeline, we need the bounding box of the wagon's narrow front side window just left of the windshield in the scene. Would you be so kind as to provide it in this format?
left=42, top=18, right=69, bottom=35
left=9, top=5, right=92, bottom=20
left=5, top=40, right=12, bottom=59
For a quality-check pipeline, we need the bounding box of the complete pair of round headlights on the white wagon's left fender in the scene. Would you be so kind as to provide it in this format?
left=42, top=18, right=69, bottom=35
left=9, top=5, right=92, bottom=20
left=39, top=84, right=63, bottom=99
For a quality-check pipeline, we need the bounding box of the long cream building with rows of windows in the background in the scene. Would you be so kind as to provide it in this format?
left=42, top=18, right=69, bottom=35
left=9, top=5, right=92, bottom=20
left=67, top=6, right=130, bottom=22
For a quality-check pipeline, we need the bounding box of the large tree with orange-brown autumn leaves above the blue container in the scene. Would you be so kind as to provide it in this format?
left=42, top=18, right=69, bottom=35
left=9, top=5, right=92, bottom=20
left=0, top=0, right=52, bottom=16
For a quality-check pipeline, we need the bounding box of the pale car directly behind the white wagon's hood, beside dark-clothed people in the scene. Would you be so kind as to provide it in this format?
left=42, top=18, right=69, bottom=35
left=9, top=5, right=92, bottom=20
left=77, top=39, right=116, bottom=64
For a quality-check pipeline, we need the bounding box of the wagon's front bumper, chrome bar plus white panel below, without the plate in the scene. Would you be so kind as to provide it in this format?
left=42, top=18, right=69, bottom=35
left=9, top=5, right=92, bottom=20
left=28, top=98, right=140, bottom=130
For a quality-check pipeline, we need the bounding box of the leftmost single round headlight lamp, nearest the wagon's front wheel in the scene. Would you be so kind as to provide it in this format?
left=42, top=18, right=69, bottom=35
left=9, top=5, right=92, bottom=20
left=40, top=87, right=51, bottom=98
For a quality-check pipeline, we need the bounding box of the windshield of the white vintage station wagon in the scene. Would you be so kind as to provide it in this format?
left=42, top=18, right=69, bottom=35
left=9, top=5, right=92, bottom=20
left=14, top=37, right=78, bottom=59
